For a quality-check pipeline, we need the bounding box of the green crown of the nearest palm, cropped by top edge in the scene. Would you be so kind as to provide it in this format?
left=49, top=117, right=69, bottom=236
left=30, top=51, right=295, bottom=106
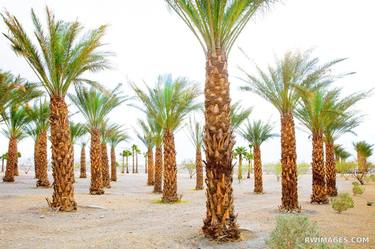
left=166, top=0, right=276, bottom=55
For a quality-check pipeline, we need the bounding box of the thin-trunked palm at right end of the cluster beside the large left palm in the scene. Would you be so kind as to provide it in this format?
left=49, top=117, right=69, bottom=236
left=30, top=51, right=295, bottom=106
left=108, top=125, right=129, bottom=182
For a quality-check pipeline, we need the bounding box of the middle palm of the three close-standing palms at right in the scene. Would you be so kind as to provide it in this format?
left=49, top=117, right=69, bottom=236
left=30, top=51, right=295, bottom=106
left=295, top=89, right=342, bottom=204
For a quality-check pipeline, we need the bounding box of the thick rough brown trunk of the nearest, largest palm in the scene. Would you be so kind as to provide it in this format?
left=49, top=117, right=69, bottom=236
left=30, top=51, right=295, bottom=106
left=202, top=51, right=240, bottom=240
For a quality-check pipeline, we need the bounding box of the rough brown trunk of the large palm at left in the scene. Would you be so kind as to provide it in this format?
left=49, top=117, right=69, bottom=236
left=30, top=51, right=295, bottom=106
left=50, top=97, right=77, bottom=211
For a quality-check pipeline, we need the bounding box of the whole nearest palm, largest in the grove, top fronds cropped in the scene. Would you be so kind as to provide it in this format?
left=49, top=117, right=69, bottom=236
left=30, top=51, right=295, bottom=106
left=166, top=0, right=275, bottom=237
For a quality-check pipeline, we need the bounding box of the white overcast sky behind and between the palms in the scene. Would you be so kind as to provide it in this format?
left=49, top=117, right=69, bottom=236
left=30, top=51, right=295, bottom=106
left=0, top=0, right=375, bottom=165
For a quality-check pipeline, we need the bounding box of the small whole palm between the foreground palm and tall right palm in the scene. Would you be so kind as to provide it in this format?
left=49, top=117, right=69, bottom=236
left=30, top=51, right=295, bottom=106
left=240, top=120, right=277, bottom=194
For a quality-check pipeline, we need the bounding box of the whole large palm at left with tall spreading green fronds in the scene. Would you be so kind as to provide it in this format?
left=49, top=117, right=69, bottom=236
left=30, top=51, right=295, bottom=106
left=2, top=8, right=108, bottom=211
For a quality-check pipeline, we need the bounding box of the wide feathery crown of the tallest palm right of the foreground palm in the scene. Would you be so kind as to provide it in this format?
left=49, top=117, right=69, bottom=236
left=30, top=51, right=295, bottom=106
left=241, top=50, right=345, bottom=113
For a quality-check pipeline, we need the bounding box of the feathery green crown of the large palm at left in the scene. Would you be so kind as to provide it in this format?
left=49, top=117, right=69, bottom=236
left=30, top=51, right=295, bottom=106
left=1, top=7, right=109, bottom=97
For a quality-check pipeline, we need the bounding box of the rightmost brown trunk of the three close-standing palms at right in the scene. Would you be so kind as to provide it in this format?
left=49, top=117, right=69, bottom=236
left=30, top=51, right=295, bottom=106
left=325, top=142, right=337, bottom=196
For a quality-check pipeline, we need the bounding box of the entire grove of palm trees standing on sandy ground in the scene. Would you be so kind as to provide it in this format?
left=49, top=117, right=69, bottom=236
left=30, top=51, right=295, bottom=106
left=0, top=0, right=372, bottom=243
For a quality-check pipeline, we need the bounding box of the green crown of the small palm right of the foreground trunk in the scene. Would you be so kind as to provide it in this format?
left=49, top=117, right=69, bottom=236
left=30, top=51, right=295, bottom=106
left=239, top=120, right=278, bottom=146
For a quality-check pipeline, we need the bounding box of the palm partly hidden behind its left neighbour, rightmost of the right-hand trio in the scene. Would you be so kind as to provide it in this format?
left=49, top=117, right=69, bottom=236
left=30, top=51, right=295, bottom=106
left=324, top=93, right=366, bottom=196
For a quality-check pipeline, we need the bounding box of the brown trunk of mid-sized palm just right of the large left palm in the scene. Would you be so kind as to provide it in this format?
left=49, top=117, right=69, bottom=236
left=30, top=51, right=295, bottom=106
left=90, top=128, right=104, bottom=195
